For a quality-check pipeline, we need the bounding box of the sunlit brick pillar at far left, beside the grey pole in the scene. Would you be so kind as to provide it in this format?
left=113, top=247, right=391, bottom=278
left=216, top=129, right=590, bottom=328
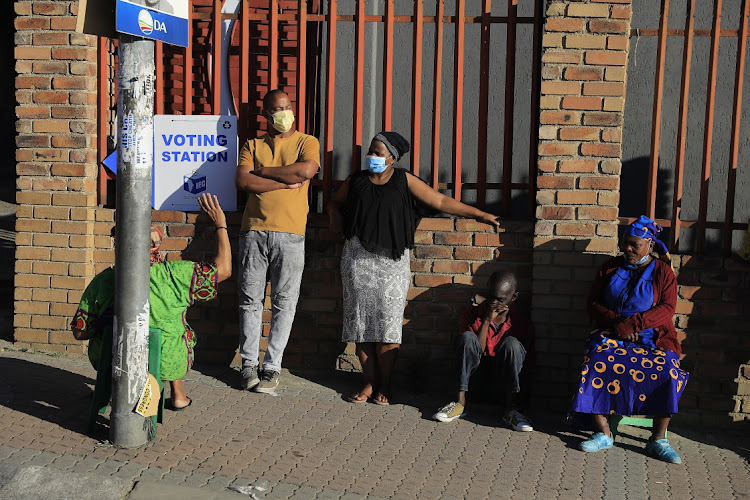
left=14, top=0, right=97, bottom=351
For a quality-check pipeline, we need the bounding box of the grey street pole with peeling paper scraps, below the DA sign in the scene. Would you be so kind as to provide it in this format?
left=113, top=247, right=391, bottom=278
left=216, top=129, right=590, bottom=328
left=110, top=34, right=154, bottom=448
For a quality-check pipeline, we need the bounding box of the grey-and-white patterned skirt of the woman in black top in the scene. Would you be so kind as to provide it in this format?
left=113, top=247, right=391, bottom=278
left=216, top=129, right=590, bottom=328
left=341, top=236, right=411, bottom=344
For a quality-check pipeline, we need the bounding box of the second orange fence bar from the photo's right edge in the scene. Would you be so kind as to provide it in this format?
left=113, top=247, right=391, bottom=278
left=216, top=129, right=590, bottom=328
left=697, top=0, right=722, bottom=253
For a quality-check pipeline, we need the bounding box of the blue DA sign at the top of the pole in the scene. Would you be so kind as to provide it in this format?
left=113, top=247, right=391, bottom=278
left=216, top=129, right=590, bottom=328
left=115, top=0, right=189, bottom=47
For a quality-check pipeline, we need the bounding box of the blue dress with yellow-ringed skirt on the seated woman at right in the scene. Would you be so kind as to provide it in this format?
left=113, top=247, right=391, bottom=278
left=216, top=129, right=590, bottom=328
left=570, top=261, right=689, bottom=415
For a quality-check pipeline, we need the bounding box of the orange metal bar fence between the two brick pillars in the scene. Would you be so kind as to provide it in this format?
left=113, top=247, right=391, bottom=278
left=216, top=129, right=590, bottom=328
left=98, top=0, right=544, bottom=217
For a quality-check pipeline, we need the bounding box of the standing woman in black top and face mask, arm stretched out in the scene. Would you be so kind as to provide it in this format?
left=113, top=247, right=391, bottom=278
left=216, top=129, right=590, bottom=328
left=327, top=132, right=499, bottom=405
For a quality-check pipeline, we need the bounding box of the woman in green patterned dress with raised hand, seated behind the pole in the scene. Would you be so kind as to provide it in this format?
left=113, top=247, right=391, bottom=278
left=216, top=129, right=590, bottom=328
left=70, top=193, right=232, bottom=410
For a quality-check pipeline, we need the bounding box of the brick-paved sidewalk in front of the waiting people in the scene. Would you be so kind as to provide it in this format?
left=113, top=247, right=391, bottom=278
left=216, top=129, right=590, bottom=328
left=0, top=347, right=750, bottom=500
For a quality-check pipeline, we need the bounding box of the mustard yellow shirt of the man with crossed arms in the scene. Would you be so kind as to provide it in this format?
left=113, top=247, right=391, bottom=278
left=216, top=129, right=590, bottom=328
left=239, top=130, right=320, bottom=236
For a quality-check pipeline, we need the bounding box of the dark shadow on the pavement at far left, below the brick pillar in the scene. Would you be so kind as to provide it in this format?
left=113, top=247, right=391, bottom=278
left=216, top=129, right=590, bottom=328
left=0, top=358, right=95, bottom=434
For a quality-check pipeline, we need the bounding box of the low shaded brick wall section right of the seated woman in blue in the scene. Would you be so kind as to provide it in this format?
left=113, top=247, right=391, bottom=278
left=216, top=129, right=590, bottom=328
left=674, top=255, right=750, bottom=425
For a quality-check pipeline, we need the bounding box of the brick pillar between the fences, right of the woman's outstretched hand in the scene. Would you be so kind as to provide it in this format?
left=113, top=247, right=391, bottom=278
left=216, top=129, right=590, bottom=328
left=533, top=0, right=631, bottom=410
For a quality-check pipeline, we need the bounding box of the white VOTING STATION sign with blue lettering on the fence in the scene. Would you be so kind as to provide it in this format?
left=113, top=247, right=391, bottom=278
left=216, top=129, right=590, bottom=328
left=152, top=115, right=237, bottom=212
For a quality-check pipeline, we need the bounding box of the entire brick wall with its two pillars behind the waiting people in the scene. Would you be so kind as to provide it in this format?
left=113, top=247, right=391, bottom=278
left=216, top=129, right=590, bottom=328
left=14, top=0, right=750, bottom=425
